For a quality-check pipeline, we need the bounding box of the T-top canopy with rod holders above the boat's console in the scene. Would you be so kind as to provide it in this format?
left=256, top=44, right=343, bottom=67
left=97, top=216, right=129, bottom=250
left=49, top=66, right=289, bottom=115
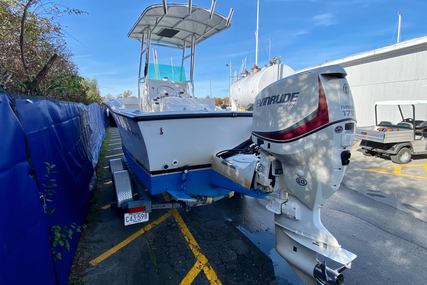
left=128, top=1, right=233, bottom=48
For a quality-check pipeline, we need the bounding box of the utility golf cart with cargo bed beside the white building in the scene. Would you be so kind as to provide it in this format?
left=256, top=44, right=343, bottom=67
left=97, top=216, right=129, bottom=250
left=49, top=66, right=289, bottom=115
left=356, top=100, right=427, bottom=164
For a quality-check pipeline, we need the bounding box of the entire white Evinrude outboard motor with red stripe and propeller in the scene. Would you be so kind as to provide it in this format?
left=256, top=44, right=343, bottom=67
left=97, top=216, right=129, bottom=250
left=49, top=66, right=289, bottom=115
left=213, top=65, right=356, bottom=285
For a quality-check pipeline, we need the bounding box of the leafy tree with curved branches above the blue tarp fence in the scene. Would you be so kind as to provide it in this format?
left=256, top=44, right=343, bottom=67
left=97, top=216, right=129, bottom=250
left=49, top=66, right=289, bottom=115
left=0, top=0, right=101, bottom=104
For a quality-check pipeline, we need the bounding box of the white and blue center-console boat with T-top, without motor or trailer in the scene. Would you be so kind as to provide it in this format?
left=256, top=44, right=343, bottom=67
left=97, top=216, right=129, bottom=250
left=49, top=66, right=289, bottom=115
left=104, top=1, right=258, bottom=201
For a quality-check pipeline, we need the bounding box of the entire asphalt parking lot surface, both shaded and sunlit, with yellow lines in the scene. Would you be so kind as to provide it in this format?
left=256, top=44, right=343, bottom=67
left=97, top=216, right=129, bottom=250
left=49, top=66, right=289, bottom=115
left=79, top=128, right=427, bottom=285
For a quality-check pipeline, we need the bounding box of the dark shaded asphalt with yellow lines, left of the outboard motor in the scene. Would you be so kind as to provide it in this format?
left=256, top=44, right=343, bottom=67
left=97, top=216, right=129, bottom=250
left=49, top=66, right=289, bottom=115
left=86, top=128, right=277, bottom=284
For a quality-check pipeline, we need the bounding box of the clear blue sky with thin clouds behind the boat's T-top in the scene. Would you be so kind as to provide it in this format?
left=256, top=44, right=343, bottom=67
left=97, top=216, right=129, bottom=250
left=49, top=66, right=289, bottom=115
left=60, top=0, right=427, bottom=97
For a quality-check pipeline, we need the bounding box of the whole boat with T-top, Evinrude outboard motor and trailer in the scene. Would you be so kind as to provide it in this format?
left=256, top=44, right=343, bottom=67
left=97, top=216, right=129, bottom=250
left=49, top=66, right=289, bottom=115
left=104, top=0, right=356, bottom=285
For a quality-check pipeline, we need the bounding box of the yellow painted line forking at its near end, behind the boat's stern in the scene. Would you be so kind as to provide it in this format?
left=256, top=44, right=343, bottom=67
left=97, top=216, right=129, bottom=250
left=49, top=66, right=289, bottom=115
left=171, top=209, right=222, bottom=285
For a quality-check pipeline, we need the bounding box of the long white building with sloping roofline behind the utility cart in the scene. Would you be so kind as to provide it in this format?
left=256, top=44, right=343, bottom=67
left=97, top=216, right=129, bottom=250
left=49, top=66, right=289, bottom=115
left=297, top=36, right=427, bottom=126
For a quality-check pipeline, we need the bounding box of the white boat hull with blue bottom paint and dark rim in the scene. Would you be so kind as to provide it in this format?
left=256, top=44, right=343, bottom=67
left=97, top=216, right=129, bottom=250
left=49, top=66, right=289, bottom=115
left=112, top=110, right=252, bottom=197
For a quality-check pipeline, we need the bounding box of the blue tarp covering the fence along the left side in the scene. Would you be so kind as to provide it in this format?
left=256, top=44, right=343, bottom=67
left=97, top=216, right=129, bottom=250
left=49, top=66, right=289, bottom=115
left=0, top=90, right=106, bottom=284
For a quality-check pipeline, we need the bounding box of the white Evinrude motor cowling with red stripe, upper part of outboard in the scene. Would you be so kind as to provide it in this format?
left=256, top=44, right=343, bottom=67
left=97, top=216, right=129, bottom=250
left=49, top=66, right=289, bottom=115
left=252, top=66, right=355, bottom=208
